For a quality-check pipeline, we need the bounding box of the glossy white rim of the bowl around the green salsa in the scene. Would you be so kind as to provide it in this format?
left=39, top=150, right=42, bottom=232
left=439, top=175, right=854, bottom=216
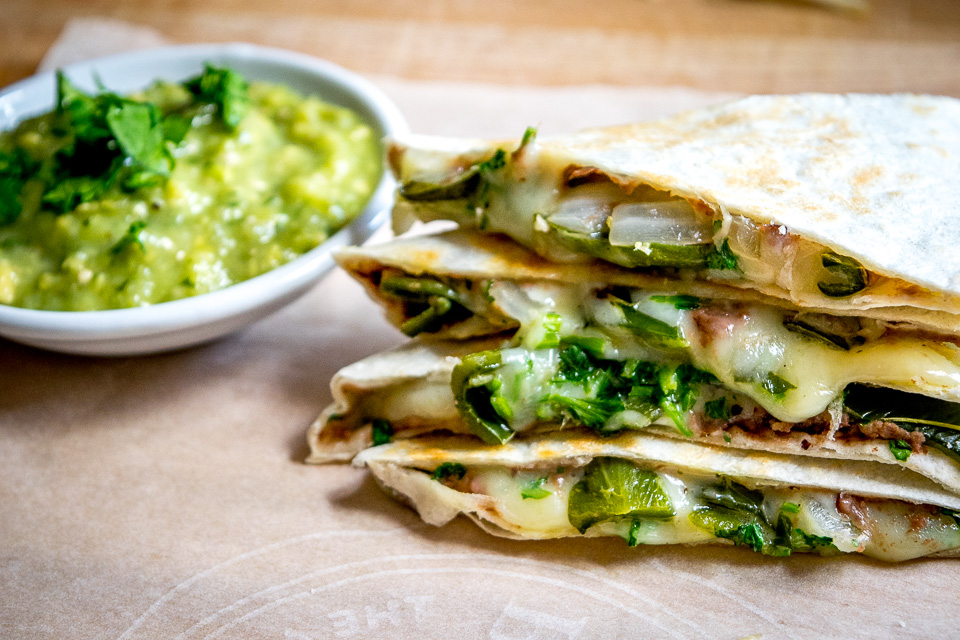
left=0, top=42, right=409, bottom=341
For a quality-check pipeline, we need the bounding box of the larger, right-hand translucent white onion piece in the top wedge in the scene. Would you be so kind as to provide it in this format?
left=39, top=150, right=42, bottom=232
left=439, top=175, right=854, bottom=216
left=610, top=200, right=713, bottom=247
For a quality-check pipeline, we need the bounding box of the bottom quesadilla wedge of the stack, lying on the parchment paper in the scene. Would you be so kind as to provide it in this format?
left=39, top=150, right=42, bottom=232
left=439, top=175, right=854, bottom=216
left=355, top=432, right=960, bottom=561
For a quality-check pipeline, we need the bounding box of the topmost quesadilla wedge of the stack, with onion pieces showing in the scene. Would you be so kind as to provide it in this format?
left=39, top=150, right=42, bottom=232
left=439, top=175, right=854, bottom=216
left=389, top=94, right=960, bottom=313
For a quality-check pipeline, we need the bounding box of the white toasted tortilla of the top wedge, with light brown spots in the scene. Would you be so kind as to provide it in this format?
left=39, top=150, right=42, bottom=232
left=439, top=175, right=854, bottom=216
left=390, top=94, right=960, bottom=313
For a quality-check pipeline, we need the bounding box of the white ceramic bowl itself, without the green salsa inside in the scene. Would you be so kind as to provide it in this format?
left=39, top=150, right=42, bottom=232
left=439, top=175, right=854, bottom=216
left=0, top=44, right=407, bottom=356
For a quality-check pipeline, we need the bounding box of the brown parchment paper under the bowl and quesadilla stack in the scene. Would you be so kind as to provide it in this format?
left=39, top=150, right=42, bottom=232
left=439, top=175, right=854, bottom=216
left=0, top=21, right=960, bottom=640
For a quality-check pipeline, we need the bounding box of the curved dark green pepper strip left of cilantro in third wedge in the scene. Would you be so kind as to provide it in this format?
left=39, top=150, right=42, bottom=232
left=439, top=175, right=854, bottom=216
left=450, top=351, right=514, bottom=444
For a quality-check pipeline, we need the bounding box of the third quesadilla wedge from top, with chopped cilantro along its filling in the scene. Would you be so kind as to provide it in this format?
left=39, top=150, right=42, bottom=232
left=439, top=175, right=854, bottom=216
left=316, top=339, right=960, bottom=495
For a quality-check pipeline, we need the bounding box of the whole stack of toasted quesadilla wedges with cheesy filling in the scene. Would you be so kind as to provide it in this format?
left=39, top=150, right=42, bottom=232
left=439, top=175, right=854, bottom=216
left=308, top=95, right=960, bottom=560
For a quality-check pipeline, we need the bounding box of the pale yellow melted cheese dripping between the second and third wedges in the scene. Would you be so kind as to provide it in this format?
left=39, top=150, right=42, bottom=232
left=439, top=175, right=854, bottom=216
left=491, top=284, right=960, bottom=428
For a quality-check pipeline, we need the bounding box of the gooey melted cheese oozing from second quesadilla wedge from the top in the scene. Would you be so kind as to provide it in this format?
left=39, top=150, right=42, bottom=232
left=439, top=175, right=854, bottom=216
left=490, top=283, right=960, bottom=423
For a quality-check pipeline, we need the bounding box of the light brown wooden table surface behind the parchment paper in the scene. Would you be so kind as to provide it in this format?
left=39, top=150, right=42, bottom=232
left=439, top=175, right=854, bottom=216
left=0, top=0, right=960, bottom=96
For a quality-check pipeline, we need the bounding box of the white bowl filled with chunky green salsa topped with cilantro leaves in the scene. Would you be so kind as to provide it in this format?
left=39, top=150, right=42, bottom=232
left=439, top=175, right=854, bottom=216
left=0, top=45, right=406, bottom=355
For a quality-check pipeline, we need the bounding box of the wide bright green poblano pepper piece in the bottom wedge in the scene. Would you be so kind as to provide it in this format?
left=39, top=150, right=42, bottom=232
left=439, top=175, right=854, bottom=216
left=567, top=458, right=676, bottom=533
